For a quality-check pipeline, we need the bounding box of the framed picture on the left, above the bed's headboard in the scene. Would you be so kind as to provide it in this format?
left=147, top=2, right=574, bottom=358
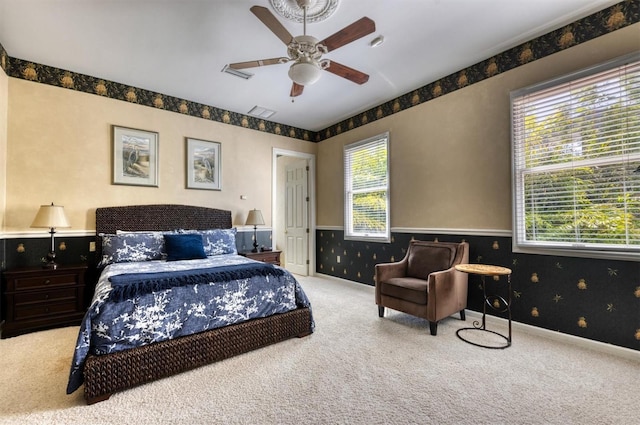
left=113, top=125, right=158, bottom=187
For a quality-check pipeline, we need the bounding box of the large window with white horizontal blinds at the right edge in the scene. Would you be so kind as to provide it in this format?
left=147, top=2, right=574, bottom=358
left=511, top=53, right=640, bottom=259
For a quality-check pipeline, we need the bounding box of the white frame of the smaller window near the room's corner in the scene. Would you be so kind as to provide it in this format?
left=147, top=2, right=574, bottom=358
left=343, top=131, right=391, bottom=243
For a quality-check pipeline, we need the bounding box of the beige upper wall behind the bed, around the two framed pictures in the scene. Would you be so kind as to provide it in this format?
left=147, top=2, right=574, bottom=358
left=0, top=78, right=317, bottom=232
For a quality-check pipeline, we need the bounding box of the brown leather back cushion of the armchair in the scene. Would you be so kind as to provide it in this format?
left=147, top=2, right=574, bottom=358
left=407, top=242, right=457, bottom=280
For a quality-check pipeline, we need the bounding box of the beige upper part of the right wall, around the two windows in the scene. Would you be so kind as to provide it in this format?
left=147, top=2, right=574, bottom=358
left=316, top=24, right=640, bottom=230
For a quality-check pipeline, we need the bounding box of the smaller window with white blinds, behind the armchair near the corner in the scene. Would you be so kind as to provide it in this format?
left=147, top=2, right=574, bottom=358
left=344, top=133, right=391, bottom=242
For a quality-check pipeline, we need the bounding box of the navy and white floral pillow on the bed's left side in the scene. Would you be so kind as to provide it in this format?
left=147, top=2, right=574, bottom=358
left=99, top=232, right=165, bottom=267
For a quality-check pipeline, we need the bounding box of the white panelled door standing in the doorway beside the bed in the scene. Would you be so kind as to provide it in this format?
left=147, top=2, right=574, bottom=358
left=285, top=160, right=309, bottom=276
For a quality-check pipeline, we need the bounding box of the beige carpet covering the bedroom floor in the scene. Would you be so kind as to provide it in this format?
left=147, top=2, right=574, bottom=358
left=0, top=277, right=640, bottom=425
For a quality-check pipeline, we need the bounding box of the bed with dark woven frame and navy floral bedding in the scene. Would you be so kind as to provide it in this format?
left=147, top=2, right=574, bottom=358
left=67, top=204, right=314, bottom=404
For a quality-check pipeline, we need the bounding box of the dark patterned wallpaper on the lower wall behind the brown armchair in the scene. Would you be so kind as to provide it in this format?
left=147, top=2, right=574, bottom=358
left=316, top=230, right=640, bottom=350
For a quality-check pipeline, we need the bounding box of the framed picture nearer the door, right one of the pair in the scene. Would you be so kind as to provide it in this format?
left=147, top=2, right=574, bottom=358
left=187, top=138, right=222, bottom=190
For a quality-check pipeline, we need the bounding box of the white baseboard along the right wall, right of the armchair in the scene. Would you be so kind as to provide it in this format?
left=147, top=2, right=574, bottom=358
left=465, top=310, right=640, bottom=362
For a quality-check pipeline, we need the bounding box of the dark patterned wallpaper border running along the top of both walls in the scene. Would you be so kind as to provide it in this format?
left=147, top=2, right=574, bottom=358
left=0, top=0, right=640, bottom=142
